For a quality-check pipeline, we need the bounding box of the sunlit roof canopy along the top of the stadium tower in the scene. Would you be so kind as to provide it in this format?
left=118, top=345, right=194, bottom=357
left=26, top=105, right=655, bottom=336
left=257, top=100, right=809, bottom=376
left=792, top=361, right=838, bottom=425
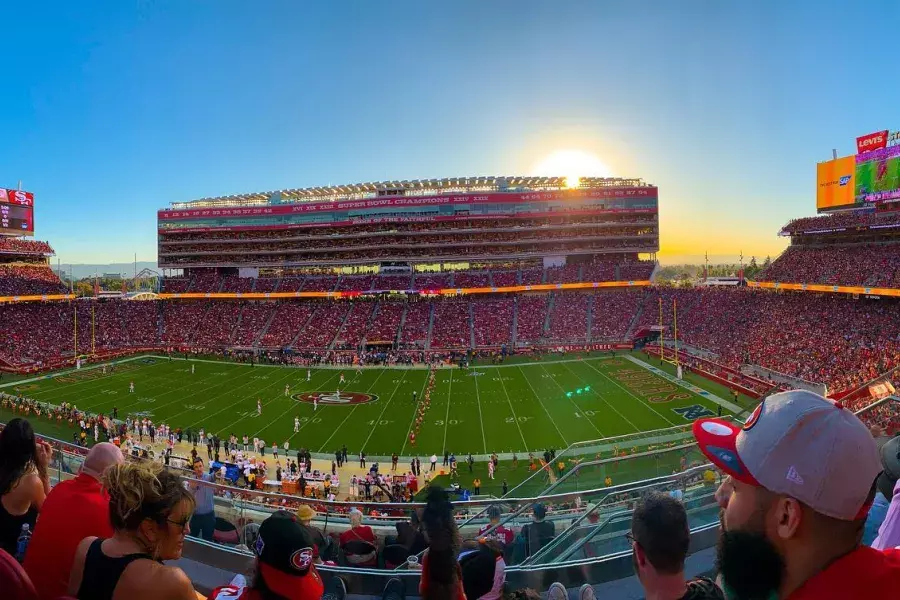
left=170, top=176, right=647, bottom=210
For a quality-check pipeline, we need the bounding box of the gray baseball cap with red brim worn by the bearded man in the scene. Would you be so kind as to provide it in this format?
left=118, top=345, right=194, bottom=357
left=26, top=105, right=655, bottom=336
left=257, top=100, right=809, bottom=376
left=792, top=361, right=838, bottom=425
left=693, top=390, right=882, bottom=521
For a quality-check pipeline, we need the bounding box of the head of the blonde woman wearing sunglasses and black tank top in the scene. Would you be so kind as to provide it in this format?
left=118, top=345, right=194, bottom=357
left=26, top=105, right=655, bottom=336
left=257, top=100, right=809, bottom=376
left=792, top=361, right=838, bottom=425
left=102, top=462, right=194, bottom=560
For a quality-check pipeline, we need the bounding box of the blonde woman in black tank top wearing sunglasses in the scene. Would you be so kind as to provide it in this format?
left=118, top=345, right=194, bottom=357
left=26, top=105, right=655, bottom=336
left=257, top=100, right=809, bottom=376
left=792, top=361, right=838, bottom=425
left=68, top=463, right=195, bottom=600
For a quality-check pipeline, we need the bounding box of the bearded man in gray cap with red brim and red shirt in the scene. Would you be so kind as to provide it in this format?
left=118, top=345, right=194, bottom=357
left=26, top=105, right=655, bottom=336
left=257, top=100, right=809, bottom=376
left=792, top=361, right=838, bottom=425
left=693, top=390, right=900, bottom=600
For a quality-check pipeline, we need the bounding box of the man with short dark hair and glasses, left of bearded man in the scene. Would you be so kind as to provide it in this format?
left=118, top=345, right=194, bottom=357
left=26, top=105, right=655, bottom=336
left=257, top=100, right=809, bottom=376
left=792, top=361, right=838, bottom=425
left=625, top=492, right=724, bottom=600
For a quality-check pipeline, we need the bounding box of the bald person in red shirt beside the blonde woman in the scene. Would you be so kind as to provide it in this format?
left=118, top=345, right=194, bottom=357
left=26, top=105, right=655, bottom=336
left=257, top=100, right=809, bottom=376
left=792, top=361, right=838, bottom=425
left=23, top=442, right=124, bottom=600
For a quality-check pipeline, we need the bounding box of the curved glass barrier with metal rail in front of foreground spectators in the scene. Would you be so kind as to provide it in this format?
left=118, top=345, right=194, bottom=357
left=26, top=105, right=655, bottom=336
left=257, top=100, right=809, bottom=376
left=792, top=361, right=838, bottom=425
left=0, top=418, right=718, bottom=569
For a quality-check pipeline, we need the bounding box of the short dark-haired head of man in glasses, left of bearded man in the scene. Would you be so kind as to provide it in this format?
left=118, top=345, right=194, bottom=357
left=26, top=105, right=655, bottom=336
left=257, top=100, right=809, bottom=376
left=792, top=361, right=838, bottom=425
left=631, top=492, right=691, bottom=597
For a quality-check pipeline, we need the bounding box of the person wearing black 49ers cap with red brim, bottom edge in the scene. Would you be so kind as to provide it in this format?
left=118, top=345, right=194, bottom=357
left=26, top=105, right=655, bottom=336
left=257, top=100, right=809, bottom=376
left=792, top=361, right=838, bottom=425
left=209, top=511, right=326, bottom=600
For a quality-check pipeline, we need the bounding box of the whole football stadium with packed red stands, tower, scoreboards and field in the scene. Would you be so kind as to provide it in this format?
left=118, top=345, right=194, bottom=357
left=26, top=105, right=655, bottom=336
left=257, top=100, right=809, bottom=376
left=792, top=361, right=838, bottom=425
left=0, top=146, right=900, bottom=594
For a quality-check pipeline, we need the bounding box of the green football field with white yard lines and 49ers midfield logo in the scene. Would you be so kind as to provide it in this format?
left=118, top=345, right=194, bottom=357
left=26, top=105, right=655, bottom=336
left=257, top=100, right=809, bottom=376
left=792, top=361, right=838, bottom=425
left=0, top=353, right=736, bottom=456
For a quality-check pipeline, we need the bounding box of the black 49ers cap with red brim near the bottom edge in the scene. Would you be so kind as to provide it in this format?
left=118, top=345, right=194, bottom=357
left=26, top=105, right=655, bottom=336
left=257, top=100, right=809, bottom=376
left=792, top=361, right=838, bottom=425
left=253, top=511, right=325, bottom=600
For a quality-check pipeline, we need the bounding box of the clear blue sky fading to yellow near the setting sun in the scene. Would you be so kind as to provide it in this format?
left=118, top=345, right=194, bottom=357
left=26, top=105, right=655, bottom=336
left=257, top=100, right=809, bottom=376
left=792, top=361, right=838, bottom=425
left=0, top=0, right=900, bottom=263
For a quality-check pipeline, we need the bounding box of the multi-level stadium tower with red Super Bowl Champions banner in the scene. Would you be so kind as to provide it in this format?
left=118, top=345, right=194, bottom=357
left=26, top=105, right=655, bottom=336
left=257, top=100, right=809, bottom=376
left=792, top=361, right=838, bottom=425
left=157, top=177, right=659, bottom=277
